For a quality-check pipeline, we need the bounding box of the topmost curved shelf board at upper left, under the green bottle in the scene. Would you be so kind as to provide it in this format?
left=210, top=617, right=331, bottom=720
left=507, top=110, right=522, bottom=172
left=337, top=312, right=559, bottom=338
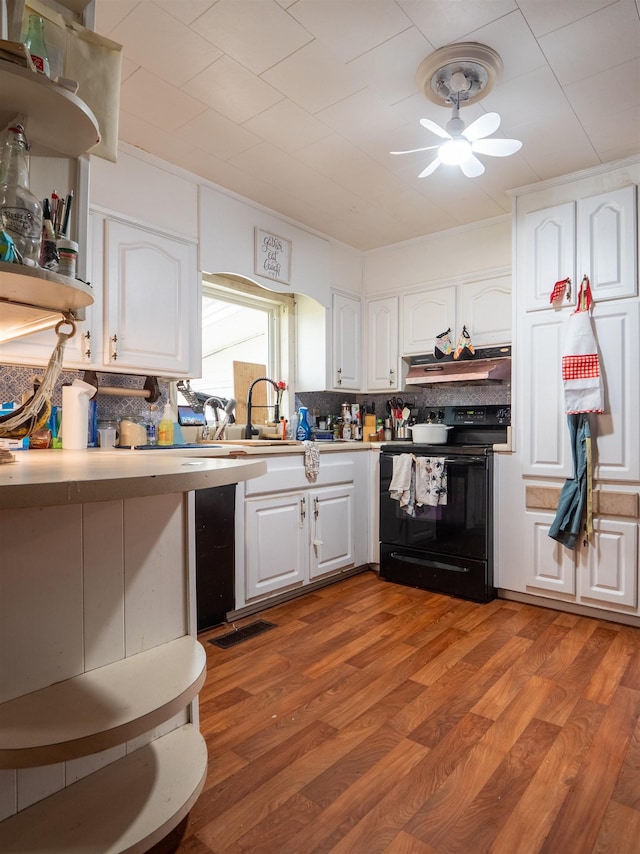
left=0, top=60, right=100, bottom=157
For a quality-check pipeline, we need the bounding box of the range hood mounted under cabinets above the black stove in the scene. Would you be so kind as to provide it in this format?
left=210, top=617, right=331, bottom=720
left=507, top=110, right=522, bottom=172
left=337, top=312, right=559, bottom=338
left=404, top=346, right=511, bottom=387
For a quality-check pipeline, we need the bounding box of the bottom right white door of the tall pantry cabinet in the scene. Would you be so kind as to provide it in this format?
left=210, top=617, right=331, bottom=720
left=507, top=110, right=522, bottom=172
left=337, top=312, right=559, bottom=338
left=578, top=519, right=638, bottom=608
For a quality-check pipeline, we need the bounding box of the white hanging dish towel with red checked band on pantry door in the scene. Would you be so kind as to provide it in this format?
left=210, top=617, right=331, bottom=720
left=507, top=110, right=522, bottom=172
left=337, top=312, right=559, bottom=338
left=562, top=276, right=604, bottom=415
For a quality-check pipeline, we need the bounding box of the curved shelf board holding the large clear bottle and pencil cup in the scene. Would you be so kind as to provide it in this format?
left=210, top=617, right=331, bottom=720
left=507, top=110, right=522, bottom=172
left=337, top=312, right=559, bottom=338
left=0, top=261, right=93, bottom=316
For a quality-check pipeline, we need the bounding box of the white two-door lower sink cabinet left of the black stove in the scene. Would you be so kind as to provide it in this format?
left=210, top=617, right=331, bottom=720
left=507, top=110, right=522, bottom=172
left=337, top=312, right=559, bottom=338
left=236, top=452, right=369, bottom=608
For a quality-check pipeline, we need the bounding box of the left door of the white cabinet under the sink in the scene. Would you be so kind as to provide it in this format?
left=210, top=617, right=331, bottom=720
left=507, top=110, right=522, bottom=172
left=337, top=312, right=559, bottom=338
left=245, top=492, right=309, bottom=601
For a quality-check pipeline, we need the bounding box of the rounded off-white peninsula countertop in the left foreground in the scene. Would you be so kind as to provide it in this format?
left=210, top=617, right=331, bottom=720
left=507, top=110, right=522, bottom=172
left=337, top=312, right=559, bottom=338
left=0, top=448, right=267, bottom=509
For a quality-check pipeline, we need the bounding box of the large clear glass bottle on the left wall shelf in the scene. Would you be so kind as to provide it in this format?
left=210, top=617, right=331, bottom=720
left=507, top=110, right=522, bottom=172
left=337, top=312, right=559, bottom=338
left=0, top=125, right=42, bottom=266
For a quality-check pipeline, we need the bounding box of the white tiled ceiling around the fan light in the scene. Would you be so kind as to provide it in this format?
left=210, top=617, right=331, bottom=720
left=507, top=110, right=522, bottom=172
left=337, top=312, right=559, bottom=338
left=96, top=0, right=640, bottom=250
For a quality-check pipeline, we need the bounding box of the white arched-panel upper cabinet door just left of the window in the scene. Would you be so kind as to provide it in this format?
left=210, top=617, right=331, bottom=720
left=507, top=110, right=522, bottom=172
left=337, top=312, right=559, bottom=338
left=104, top=218, right=200, bottom=375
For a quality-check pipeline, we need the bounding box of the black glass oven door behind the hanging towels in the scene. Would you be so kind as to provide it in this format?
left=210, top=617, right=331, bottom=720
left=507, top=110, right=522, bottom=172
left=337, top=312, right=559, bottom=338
left=380, top=453, right=492, bottom=561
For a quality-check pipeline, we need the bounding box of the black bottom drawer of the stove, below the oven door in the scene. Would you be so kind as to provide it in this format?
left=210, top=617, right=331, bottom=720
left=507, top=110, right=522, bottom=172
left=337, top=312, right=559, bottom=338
left=380, top=543, right=496, bottom=602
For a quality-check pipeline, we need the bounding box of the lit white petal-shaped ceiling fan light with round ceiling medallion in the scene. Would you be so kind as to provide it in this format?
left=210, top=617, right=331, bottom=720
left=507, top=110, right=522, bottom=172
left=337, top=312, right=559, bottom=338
left=390, top=42, right=522, bottom=178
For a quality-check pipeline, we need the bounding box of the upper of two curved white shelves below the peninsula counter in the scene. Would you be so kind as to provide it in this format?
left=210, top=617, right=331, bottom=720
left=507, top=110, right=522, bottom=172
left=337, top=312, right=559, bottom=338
left=0, top=636, right=206, bottom=768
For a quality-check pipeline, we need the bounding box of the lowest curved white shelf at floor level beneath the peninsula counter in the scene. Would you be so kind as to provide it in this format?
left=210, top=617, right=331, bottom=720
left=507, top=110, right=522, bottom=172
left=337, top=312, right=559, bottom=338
left=0, top=724, right=207, bottom=854
